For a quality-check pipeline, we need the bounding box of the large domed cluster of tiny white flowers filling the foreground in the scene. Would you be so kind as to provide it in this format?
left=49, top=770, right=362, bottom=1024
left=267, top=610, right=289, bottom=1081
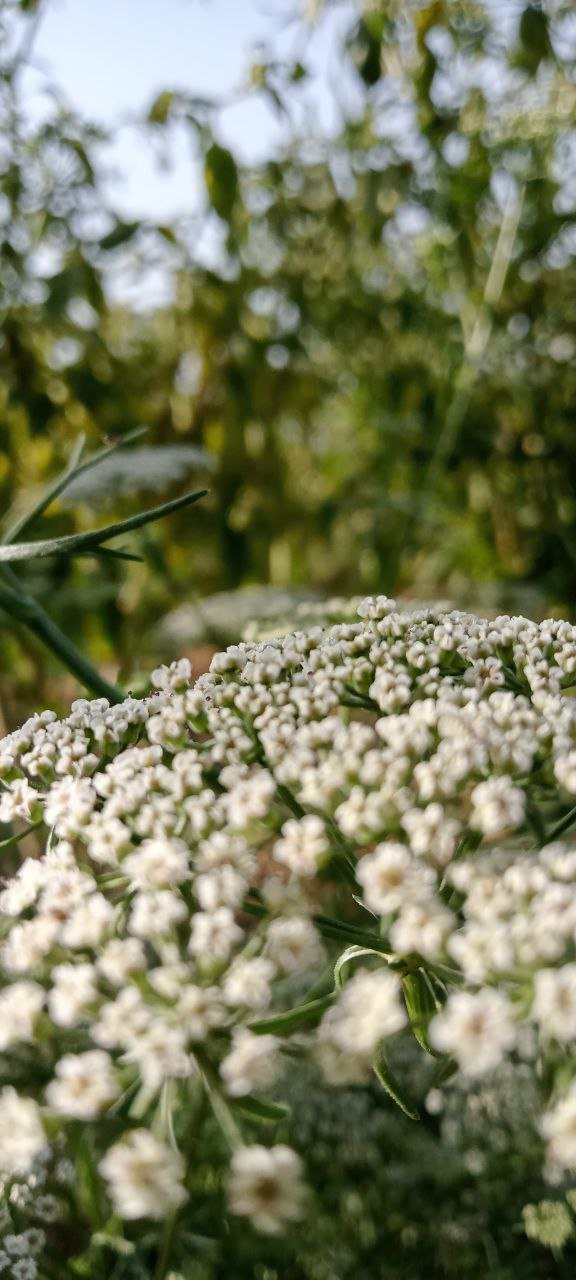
left=0, top=596, right=576, bottom=1280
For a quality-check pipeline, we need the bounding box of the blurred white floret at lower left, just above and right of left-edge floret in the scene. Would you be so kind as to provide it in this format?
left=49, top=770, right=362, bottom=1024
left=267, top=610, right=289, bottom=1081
left=46, top=1050, right=119, bottom=1120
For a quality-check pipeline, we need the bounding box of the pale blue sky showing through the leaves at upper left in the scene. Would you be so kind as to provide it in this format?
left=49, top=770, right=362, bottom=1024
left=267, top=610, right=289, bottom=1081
left=33, top=0, right=358, bottom=220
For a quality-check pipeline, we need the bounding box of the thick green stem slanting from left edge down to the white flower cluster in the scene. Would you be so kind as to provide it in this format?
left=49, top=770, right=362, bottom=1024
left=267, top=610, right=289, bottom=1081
left=0, top=570, right=125, bottom=703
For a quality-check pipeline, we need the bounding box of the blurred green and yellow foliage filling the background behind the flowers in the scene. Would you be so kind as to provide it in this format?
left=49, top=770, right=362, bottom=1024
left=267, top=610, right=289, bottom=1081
left=0, top=0, right=576, bottom=721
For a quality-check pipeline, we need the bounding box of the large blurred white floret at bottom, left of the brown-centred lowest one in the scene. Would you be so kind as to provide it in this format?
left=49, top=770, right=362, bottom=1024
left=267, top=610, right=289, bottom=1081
left=99, top=1129, right=187, bottom=1220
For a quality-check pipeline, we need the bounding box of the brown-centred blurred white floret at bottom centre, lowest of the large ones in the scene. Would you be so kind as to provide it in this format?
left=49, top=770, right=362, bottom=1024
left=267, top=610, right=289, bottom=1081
left=228, top=1144, right=305, bottom=1234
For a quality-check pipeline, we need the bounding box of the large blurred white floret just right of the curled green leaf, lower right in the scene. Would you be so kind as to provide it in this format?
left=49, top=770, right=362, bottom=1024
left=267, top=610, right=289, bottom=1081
left=429, top=988, right=517, bottom=1076
